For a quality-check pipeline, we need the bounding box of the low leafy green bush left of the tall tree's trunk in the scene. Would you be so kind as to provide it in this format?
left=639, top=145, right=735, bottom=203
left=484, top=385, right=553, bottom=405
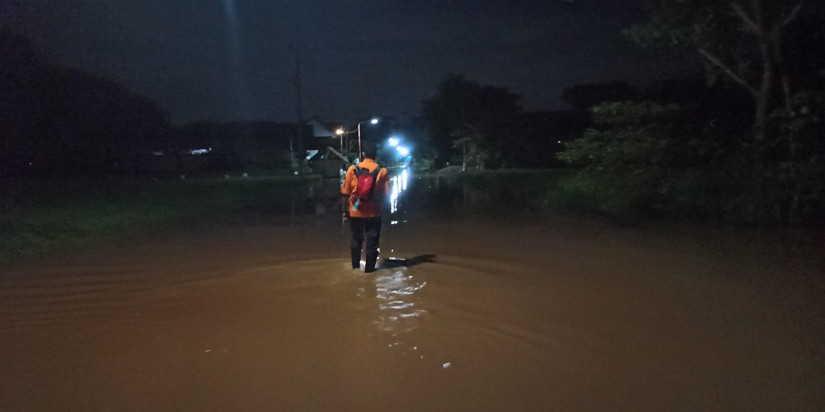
left=560, top=101, right=752, bottom=219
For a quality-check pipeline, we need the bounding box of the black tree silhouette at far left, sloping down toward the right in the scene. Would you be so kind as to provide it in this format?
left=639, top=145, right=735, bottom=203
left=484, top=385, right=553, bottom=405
left=0, top=30, right=171, bottom=175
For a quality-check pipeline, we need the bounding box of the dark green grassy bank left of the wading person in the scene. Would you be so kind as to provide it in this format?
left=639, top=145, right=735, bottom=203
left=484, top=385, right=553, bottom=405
left=0, top=175, right=321, bottom=267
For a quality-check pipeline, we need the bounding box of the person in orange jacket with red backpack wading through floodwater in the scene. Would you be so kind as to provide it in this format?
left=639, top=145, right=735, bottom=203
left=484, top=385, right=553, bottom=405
left=341, top=142, right=390, bottom=272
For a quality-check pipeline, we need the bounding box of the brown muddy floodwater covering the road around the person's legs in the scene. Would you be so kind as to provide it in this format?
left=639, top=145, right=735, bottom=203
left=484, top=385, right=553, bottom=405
left=0, top=175, right=825, bottom=412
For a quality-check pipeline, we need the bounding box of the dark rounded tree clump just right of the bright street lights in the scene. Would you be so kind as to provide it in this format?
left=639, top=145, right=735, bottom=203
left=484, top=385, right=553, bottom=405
left=418, top=75, right=584, bottom=170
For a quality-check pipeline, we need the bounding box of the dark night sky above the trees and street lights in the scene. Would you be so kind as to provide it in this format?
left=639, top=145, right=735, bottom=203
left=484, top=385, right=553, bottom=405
left=0, top=0, right=691, bottom=124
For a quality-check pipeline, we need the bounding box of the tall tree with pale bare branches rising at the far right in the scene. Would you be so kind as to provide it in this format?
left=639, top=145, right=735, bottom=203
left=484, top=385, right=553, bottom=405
left=628, top=0, right=825, bottom=224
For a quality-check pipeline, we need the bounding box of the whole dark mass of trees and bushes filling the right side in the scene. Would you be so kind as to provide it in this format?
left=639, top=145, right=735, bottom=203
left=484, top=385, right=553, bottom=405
left=560, top=0, right=825, bottom=225
